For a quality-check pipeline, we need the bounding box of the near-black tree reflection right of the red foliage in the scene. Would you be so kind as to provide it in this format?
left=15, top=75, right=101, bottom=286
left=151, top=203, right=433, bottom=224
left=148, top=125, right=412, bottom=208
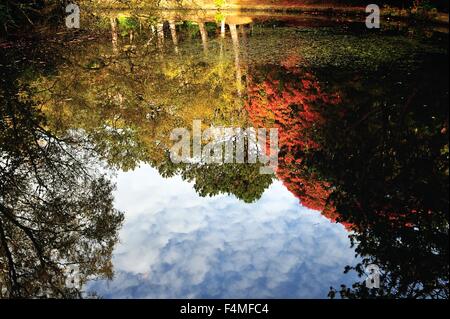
left=320, top=56, right=449, bottom=298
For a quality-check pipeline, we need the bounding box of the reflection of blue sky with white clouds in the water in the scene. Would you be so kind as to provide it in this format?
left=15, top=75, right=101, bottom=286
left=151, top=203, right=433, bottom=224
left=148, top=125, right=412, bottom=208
left=88, top=166, right=360, bottom=298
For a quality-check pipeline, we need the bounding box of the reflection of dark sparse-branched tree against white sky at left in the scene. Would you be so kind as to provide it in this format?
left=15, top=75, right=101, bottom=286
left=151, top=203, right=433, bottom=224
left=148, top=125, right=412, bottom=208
left=0, top=69, right=123, bottom=298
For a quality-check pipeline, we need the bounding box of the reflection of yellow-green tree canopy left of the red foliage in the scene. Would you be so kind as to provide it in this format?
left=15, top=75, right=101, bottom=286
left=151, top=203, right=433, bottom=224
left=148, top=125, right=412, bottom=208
left=29, top=26, right=272, bottom=202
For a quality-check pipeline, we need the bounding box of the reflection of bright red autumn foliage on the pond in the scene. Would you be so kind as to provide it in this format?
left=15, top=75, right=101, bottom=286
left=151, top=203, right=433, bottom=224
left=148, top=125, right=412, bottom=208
left=246, top=55, right=339, bottom=228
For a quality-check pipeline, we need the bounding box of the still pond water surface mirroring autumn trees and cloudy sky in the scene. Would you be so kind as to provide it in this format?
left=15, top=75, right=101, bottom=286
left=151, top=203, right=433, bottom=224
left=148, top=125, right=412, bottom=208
left=0, top=11, right=449, bottom=298
